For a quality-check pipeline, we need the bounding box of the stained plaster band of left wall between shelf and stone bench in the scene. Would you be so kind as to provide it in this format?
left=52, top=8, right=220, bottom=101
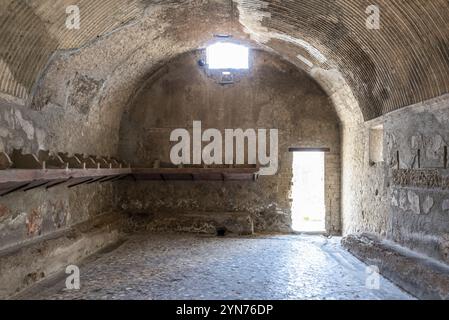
left=0, top=180, right=118, bottom=250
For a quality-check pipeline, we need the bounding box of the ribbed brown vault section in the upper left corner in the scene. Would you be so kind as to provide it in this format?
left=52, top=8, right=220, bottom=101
left=0, top=0, right=144, bottom=98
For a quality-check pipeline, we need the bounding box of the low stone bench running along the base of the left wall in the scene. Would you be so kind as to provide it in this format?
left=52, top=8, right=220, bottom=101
left=0, top=214, right=125, bottom=299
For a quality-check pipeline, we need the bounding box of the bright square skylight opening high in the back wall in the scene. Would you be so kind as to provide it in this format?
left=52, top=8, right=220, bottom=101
left=206, top=42, right=249, bottom=69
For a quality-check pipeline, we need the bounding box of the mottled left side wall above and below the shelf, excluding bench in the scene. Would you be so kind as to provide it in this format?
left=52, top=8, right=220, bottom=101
left=0, top=85, right=122, bottom=250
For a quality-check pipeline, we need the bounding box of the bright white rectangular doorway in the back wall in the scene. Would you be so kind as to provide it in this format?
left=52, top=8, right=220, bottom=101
left=292, top=151, right=326, bottom=232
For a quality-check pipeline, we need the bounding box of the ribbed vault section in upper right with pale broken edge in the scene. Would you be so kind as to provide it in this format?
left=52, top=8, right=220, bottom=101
left=237, top=0, right=449, bottom=119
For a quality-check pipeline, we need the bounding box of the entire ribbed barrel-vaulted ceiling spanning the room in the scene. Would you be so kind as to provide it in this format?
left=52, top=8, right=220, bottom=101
left=0, top=0, right=449, bottom=120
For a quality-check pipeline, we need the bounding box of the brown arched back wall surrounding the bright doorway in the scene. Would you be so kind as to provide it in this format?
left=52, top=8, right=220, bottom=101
left=115, top=51, right=340, bottom=234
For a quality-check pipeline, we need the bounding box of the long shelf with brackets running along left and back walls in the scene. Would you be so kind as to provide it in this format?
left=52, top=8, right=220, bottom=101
left=0, top=150, right=260, bottom=196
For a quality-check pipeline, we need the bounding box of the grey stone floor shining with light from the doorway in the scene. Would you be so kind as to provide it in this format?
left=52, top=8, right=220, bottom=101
left=23, top=235, right=413, bottom=300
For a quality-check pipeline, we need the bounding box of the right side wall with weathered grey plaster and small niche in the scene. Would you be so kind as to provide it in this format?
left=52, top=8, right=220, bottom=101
left=343, top=95, right=449, bottom=262
